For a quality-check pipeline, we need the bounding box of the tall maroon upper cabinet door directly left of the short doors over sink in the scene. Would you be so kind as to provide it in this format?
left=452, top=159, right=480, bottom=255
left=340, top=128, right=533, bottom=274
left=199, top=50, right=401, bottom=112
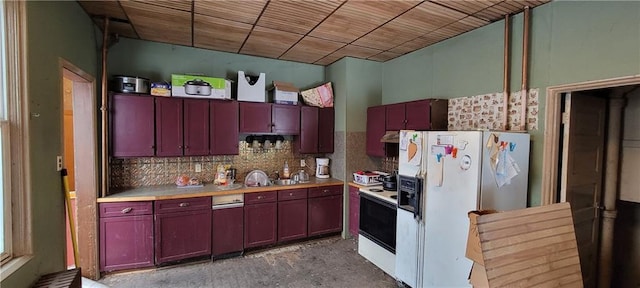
left=209, top=101, right=239, bottom=155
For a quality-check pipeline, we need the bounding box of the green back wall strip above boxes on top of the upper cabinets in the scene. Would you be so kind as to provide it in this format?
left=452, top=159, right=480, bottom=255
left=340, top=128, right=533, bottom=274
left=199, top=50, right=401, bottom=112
left=107, top=38, right=325, bottom=89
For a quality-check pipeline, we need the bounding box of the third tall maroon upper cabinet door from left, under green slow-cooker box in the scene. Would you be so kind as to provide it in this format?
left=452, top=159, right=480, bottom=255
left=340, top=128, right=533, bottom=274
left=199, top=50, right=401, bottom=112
left=183, top=99, right=209, bottom=156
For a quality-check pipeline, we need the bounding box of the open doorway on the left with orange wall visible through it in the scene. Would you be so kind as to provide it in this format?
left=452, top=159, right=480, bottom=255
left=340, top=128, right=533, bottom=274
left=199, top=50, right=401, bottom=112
left=60, top=59, right=99, bottom=279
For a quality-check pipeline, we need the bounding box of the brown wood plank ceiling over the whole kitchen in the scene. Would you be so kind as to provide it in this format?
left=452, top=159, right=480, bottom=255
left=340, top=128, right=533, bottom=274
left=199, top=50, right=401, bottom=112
left=79, top=0, right=550, bottom=65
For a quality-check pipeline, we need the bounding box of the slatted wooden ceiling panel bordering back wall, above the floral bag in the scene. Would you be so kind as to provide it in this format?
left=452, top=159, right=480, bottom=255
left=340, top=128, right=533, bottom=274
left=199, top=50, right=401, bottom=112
left=280, top=36, right=345, bottom=63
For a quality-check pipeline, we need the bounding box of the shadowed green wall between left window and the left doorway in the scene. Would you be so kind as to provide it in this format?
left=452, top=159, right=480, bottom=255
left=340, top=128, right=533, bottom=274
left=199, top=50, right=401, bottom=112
left=0, top=1, right=98, bottom=287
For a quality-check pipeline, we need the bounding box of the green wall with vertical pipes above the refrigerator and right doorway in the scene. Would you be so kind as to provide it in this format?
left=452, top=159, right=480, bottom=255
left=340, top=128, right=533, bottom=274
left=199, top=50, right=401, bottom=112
left=382, top=1, right=640, bottom=206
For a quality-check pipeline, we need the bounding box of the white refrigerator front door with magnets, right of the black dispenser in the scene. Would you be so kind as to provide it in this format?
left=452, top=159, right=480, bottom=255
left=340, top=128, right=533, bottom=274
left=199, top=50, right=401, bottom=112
left=419, top=131, right=482, bottom=287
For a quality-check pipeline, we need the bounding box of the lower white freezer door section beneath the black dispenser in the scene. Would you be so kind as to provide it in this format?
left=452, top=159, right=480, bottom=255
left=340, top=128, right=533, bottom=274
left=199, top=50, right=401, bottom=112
left=396, top=209, right=418, bottom=287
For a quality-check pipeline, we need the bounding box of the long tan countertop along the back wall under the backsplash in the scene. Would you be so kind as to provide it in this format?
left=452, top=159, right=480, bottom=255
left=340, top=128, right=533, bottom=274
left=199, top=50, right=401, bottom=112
left=98, top=177, right=344, bottom=203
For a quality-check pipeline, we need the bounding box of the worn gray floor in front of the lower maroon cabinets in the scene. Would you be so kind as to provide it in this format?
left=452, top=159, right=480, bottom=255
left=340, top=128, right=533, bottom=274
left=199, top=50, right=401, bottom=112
left=99, top=237, right=397, bottom=288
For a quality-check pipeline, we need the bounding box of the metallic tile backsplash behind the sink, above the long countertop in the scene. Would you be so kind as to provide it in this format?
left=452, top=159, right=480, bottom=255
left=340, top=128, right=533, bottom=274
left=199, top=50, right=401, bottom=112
left=109, top=140, right=324, bottom=190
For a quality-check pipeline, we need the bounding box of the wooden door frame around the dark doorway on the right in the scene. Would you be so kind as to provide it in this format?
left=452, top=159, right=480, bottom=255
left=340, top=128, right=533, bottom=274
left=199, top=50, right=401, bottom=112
left=540, top=75, right=640, bottom=205
